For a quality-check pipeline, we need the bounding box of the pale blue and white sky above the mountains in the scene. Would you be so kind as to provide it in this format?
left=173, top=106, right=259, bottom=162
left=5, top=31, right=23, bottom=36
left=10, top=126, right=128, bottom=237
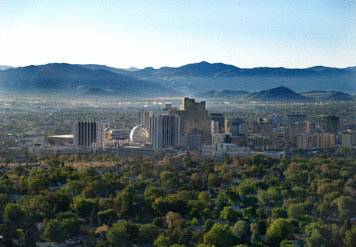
left=0, top=0, right=356, bottom=68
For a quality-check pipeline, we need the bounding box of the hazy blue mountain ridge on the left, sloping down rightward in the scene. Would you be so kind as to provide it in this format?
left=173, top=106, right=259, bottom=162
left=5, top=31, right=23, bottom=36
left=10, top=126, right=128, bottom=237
left=0, top=63, right=177, bottom=96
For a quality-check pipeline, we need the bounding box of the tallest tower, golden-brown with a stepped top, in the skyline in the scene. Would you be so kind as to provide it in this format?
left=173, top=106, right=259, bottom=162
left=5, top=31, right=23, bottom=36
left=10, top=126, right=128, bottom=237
left=177, top=98, right=211, bottom=145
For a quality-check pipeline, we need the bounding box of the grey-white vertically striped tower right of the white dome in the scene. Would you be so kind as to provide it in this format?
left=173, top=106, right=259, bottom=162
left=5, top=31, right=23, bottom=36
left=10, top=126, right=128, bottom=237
left=150, top=114, right=180, bottom=150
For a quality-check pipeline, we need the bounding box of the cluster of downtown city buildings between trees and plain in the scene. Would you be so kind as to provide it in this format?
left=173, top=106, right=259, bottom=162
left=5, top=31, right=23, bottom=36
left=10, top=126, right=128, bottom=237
left=27, top=98, right=356, bottom=158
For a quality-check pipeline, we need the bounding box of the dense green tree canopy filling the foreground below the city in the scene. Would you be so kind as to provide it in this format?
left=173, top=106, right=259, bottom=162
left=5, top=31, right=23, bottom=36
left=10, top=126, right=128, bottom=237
left=0, top=155, right=356, bottom=247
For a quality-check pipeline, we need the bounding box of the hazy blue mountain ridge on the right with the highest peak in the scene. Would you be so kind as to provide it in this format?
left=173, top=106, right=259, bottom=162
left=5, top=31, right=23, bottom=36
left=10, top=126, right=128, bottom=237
left=126, top=61, right=356, bottom=94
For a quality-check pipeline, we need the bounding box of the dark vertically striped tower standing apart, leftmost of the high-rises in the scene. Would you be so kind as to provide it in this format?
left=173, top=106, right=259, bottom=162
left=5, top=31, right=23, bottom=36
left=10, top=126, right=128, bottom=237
left=74, top=121, right=103, bottom=148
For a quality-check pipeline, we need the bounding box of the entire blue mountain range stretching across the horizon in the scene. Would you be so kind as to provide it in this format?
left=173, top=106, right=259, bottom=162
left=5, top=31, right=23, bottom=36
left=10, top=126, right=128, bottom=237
left=0, top=61, right=356, bottom=99
